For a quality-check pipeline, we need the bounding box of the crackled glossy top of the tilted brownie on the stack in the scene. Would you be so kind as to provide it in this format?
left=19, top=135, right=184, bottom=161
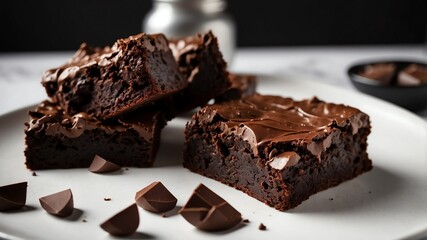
left=42, top=33, right=169, bottom=96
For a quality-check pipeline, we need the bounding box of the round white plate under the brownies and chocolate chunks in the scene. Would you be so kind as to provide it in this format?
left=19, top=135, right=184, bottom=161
left=0, top=76, right=427, bottom=239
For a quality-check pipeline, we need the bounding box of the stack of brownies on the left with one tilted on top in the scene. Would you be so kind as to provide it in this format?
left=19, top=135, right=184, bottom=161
left=25, top=32, right=236, bottom=170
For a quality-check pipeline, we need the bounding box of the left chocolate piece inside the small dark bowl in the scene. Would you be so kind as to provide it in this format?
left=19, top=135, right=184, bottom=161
left=359, top=63, right=396, bottom=85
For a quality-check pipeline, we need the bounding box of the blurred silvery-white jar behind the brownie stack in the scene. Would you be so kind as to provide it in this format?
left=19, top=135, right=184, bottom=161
left=142, top=0, right=236, bottom=64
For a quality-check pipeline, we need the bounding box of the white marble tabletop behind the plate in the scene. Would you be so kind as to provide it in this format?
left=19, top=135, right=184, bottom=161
left=0, top=45, right=427, bottom=120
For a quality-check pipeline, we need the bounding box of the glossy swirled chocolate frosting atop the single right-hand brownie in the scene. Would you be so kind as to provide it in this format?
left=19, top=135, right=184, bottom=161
left=192, top=94, right=368, bottom=152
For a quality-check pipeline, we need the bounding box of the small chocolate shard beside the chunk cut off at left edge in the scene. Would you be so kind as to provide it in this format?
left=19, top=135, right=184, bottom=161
left=39, top=189, right=74, bottom=217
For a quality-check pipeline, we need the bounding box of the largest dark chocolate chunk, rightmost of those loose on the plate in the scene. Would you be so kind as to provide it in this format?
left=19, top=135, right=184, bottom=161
left=179, top=184, right=242, bottom=231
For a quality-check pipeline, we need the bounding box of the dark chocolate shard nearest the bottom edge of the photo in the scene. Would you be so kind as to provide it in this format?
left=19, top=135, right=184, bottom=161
left=100, top=203, right=139, bottom=236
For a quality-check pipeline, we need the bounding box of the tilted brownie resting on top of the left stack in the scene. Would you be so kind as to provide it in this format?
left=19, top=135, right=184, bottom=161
left=42, top=33, right=188, bottom=119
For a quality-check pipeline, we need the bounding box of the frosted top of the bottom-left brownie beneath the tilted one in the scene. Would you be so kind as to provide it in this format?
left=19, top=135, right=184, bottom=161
left=26, top=101, right=163, bottom=139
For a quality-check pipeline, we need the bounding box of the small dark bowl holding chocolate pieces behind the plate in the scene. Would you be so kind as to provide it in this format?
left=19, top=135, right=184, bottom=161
left=347, top=60, right=427, bottom=111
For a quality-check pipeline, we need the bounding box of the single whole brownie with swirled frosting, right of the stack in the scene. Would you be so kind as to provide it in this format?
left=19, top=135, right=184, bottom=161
left=183, top=94, right=372, bottom=211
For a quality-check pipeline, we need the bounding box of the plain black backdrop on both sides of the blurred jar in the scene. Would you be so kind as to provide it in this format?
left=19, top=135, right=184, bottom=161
left=0, top=0, right=427, bottom=52
